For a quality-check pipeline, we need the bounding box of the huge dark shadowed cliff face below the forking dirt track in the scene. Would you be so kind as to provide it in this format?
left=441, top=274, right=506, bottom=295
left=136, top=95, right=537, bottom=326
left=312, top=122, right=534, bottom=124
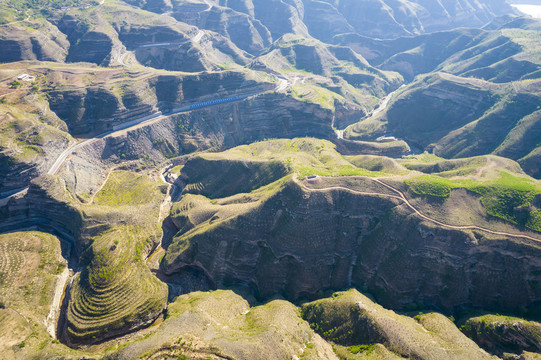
left=162, top=175, right=541, bottom=311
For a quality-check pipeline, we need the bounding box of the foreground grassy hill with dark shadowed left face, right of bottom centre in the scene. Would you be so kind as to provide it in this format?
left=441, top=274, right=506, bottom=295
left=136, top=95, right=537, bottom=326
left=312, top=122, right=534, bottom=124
left=301, top=290, right=492, bottom=359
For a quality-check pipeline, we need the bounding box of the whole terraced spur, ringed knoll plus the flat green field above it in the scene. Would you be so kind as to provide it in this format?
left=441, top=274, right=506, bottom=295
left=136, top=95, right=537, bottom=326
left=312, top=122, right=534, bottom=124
left=63, top=171, right=167, bottom=344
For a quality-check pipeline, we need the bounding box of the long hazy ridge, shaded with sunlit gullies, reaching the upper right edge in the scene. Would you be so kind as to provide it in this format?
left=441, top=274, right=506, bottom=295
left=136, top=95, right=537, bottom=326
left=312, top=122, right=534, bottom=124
left=334, top=21, right=541, bottom=83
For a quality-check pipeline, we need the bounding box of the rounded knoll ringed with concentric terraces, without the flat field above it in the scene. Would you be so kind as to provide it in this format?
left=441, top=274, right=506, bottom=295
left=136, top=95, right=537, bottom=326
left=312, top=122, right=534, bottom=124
left=66, top=224, right=167, bottom=343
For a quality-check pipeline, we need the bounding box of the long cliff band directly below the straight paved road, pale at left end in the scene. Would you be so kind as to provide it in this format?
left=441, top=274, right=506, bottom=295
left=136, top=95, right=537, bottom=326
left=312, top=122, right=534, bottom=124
left=62, top=92, right=336, bottom=197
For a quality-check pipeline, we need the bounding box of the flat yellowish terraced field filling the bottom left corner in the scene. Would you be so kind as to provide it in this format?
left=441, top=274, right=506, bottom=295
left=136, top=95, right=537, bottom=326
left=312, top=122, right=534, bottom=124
left=0, top=231, right=73, bottom=359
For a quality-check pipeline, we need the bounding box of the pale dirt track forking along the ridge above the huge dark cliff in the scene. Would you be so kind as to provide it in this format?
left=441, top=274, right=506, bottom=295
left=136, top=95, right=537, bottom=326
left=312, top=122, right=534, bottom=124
left=299, top=178, right=541, bottom=242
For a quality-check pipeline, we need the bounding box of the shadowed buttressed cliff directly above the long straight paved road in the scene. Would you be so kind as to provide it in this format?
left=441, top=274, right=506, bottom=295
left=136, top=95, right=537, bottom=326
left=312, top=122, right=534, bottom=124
left=44, top=68, right=270, bottom=135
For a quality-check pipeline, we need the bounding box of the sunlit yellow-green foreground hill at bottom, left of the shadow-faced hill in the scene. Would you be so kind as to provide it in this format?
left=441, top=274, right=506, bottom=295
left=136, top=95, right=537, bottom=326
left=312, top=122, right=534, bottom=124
left=114, top=290, right=336, bottom=359
